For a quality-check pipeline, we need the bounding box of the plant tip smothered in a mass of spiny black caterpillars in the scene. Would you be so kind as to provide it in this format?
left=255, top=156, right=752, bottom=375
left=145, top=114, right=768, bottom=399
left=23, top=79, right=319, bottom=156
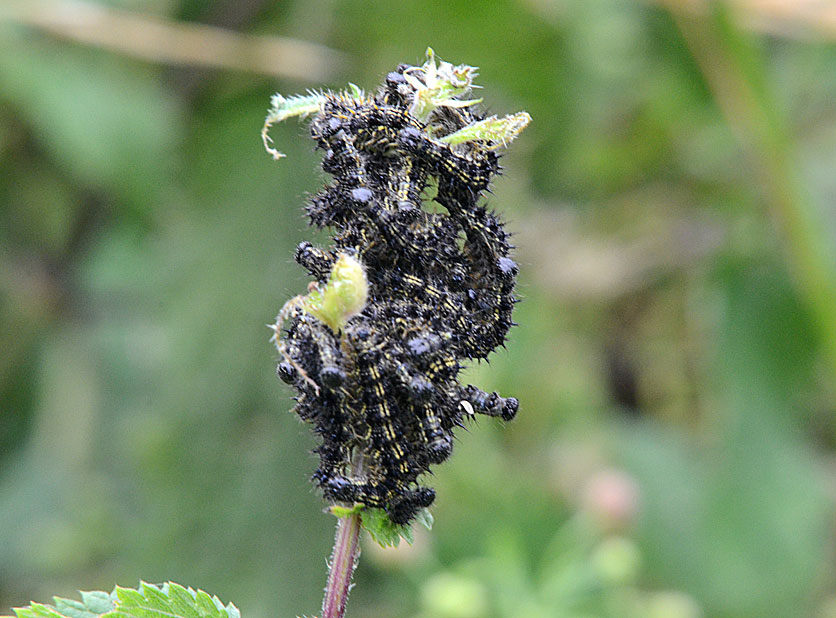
left=262, top=50, right=529, bottom=524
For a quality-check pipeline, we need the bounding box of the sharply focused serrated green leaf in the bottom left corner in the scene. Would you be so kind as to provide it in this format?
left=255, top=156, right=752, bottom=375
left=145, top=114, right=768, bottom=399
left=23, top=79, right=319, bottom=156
left=4, top=582, right=241, bottom=618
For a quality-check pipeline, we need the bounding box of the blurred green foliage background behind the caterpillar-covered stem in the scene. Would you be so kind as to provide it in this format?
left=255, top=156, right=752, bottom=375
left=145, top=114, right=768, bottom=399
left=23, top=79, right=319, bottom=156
left=0, top=0, right=836, bottom=618
